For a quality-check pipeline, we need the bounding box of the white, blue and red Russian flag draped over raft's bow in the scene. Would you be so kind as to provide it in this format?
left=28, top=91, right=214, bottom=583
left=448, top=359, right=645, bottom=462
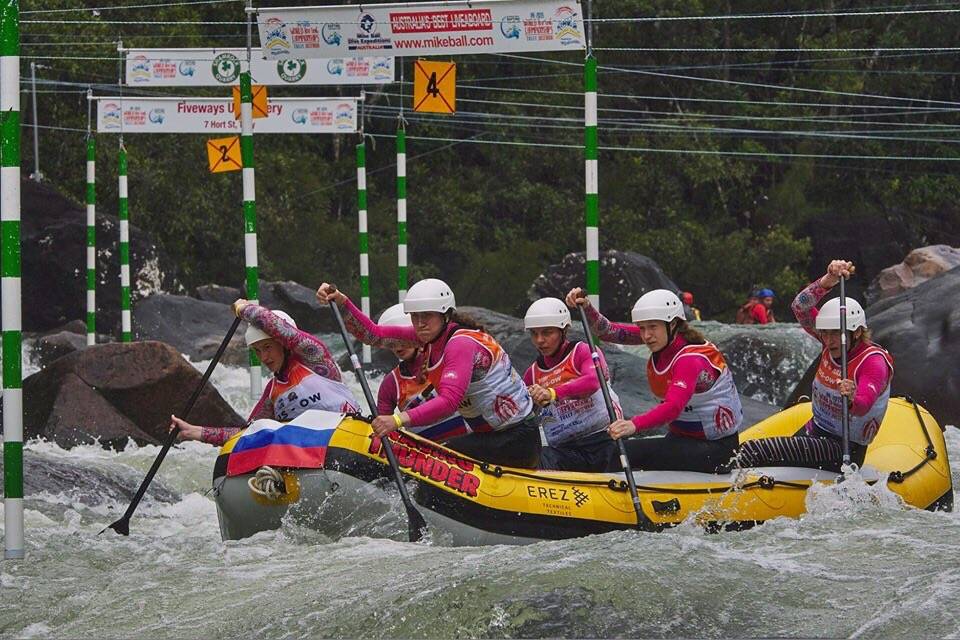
left=227, top=410, right=344, bottom=476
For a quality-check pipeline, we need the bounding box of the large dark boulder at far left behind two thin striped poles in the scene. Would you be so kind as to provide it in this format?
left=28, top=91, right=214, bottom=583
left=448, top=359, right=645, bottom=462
left=20, top=180, right=178, bottom=333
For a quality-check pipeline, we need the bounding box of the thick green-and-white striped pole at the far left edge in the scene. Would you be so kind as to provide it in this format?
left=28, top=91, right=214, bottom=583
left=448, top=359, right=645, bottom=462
left=0, top=0, right=24, bottom=559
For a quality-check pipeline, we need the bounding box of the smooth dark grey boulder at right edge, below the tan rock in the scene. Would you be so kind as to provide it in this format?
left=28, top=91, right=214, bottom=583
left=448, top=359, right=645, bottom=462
left=867, top=267, right=960, bottom=425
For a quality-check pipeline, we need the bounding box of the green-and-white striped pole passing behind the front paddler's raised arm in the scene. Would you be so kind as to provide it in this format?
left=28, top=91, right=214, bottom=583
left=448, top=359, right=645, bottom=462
left=240, top=71, right=263, bottom=399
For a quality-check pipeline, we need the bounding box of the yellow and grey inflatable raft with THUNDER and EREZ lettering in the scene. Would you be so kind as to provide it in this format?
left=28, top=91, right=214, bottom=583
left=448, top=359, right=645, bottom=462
left=214, top=398, right=953, bottom=544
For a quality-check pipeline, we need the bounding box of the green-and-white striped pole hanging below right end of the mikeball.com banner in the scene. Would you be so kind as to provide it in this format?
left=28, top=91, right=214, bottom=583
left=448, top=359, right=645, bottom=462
left=583, top=53, right=600, bottom=309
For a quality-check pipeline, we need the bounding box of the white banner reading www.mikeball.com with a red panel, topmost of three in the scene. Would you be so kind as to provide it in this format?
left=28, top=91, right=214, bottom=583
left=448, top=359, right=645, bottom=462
left=257, top=0, right=585, bottom=60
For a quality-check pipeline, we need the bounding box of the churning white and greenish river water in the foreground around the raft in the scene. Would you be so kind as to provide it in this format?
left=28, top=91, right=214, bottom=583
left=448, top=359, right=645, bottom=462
left=0, top=338, right=960, bottom=639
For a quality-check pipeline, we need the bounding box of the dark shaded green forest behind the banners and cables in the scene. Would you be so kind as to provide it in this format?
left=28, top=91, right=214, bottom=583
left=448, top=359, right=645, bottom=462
left=21, top=0, right=960, bottom=319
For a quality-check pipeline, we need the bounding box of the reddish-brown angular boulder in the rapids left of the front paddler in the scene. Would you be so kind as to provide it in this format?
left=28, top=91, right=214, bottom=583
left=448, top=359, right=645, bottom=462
left=23, top=342, right=243, bottom=448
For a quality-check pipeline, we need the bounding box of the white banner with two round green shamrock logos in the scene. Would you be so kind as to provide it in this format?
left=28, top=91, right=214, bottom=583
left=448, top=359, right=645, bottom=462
left=124, top=49, right=395, bottom=87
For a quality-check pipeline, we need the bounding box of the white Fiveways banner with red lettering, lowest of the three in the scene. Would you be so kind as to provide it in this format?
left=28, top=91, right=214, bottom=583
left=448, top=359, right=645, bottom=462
left=96, top=97, right=357, bottom=135
